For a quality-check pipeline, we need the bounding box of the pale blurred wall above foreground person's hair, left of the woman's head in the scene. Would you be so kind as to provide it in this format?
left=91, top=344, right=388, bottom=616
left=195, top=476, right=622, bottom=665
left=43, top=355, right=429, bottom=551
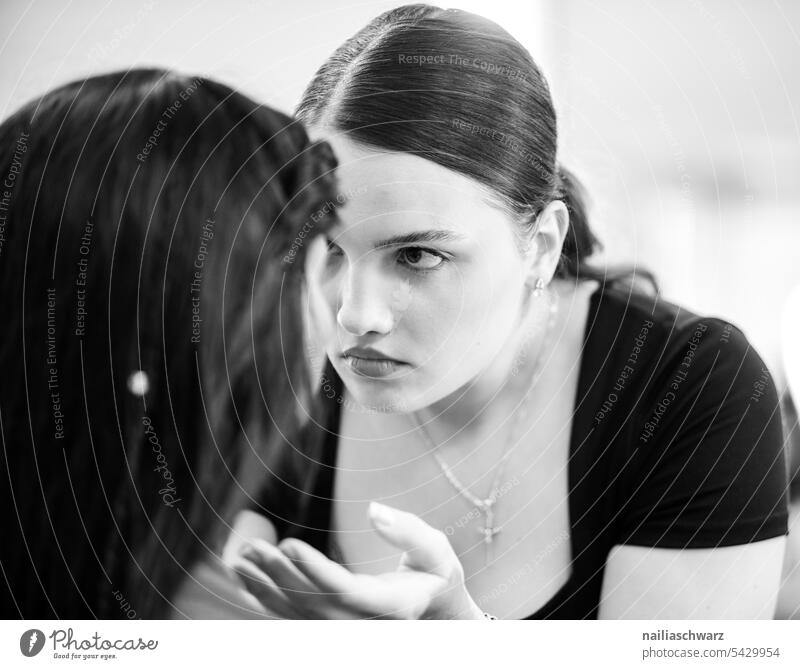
left=0, top=0, right=397, bottom=116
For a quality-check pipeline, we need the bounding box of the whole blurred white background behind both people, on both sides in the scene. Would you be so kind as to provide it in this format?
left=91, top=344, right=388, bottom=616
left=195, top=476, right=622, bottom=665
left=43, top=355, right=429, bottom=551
left=0, top=0, right=800, bottom=386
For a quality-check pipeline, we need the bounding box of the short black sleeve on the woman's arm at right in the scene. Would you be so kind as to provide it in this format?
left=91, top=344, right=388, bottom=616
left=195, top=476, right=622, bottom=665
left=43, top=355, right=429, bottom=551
left=615, top=318, right=788, bottom=548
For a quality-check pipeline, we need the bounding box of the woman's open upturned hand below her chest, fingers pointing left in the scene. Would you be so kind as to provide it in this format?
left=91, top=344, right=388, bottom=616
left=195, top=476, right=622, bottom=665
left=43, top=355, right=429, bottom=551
left=228, top=502, right=484, bottom=619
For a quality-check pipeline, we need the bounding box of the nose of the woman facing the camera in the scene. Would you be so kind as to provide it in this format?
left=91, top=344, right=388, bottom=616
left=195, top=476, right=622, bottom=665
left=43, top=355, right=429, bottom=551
left=336, top=269, right=394, bottom=336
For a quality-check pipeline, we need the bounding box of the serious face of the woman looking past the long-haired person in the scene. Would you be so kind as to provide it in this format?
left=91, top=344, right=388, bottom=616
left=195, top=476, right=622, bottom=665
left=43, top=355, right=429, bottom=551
left=308, top=135, right=526, bottom=411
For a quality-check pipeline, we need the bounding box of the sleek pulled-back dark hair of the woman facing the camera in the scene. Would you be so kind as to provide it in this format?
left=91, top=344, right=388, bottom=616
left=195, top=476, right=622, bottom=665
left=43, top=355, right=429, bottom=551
left=296, top=4, right=652, bottom=288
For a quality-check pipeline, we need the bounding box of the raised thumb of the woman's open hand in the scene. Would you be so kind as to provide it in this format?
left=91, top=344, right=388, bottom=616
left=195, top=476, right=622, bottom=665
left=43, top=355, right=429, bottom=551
left=368, top=502, right=457, bottom=577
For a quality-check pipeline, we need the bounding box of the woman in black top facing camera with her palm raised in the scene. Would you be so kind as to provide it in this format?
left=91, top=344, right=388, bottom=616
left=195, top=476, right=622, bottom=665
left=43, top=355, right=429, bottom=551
left=231, top=5, right=787, bottom=619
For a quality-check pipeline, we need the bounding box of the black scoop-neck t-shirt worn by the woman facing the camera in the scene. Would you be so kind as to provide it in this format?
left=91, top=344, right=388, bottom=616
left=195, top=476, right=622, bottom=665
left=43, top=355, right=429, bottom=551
left=258, top=285, right=788, bottom=620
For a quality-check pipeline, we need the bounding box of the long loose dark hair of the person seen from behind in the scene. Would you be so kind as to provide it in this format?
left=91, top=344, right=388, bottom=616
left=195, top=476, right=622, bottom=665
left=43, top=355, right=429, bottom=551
left=0, top=69, right=335, bottom=618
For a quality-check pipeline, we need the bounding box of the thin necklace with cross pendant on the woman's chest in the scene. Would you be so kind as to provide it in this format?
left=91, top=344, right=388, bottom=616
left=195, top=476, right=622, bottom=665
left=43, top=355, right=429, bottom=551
left=411, top=291, right=558, bottom=564
